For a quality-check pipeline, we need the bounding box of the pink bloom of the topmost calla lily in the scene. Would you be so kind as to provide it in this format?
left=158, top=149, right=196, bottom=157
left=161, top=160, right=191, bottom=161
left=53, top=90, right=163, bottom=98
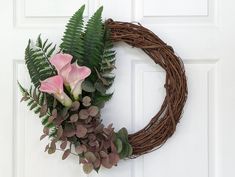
left=50, top=53, right=73, bottom=72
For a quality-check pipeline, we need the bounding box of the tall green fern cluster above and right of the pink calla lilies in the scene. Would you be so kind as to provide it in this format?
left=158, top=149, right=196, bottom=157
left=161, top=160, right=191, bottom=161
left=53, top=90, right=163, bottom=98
left=60, top=6, right=115, bottom=107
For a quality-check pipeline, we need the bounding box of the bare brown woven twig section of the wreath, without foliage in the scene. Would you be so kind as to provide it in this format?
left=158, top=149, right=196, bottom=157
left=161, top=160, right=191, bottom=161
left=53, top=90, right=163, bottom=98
left=106, top=19, right=188, bottom=158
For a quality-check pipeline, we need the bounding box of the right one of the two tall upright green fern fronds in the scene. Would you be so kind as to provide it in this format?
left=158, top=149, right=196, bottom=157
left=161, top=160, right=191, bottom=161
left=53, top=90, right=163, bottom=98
left=83, top=7, right=104, bottom=71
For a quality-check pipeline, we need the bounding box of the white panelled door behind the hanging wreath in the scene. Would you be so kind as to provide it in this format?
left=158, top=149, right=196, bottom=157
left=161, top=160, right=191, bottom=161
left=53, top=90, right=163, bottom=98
left=0, top=0, right=235, bottom=177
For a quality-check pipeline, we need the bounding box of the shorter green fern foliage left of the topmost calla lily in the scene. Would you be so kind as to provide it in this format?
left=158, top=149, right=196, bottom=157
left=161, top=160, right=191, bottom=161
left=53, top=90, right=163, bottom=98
left=25, top=37, right=56, bottom=88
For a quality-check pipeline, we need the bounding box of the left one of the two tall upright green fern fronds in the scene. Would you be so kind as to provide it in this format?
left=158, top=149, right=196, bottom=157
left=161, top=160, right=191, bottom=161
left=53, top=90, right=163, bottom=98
left=60, top=5, right=85, bottom=63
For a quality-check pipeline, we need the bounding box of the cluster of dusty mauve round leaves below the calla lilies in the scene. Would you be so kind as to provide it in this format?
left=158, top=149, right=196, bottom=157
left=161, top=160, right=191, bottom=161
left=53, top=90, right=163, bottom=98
left=41, top=96, right=120, bottom=173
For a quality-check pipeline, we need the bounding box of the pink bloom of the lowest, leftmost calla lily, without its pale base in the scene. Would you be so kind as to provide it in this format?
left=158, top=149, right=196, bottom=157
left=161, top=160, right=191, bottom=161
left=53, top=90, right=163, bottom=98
left=39, top=76, right=63, bottom=94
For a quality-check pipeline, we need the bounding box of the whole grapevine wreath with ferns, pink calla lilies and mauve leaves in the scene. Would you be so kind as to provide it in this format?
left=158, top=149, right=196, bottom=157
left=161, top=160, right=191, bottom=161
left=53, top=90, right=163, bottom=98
left=19, top=6, right=187, bottom=174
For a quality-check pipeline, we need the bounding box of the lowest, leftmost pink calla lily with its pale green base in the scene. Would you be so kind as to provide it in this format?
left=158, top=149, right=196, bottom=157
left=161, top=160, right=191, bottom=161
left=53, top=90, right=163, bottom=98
left=39, top=76, right=72, bottom=107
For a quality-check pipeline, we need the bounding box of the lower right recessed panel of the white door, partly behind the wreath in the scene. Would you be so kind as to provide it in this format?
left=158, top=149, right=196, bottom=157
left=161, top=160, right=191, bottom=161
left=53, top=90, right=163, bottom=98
left=134, top=61, right=216, bottom=177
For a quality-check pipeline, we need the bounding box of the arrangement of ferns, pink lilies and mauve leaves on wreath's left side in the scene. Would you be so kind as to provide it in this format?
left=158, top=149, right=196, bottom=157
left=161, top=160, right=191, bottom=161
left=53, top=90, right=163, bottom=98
left=19, top=6, right=133, bottom=174
